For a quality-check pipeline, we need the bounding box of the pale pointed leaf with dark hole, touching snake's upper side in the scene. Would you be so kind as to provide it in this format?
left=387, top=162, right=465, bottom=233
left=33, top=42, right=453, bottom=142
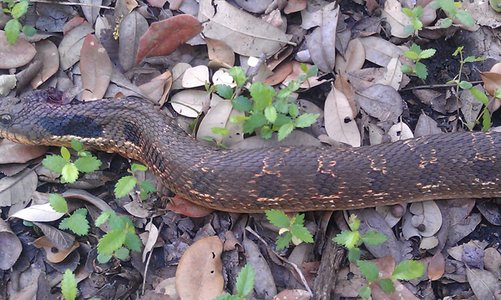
left=324, top=86, right=361, bottom=147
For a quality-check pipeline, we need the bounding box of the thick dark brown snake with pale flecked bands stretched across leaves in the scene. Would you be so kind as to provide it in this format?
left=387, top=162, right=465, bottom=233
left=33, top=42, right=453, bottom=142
left=0, top=91, right=501, bottom=212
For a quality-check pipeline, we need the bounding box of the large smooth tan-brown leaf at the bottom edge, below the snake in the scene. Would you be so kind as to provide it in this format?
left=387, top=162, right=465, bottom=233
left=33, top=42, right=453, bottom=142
left=176, top=236, right=224, bottom=300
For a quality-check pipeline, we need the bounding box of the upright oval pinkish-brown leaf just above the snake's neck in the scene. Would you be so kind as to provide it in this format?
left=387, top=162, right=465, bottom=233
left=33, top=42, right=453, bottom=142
left=80, top=34, right=112, bottom=100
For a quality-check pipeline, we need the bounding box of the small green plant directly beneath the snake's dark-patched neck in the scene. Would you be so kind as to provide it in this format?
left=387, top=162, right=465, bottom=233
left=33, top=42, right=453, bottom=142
left=42, top=140, right=101, bottom=183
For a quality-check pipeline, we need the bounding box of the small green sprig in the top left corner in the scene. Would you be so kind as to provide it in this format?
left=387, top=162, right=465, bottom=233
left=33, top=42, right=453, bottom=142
left=2, top=0, right=36, bottom=44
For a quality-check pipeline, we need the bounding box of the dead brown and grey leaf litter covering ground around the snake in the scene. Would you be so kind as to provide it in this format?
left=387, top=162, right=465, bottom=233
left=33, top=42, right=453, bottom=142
left=0, top=0, right=501, bottom=299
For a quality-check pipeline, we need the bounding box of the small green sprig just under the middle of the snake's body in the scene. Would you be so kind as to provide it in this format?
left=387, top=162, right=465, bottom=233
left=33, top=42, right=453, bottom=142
left=265, top=209, right=313, bottom=250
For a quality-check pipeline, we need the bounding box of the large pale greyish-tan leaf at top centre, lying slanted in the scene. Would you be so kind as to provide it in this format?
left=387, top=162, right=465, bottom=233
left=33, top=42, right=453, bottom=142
left=199, top=0, right=292, bottom=57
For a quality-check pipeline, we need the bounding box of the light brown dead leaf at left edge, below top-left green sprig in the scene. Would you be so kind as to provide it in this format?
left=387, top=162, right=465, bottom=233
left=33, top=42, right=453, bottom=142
left=0, top=30, right=36, bottom=69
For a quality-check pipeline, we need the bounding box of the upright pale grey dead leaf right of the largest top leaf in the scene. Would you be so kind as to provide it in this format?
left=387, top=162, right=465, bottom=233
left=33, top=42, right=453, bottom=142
left=306, top=2, right=339, bottom=73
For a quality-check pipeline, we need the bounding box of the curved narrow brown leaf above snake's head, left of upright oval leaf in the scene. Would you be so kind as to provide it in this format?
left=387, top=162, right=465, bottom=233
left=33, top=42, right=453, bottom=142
left=31, top=40, right=59, bottom=89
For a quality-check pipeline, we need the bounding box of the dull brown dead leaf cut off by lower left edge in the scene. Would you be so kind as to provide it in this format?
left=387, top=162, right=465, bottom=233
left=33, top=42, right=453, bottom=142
left=0, top=218, right=23, bottom=270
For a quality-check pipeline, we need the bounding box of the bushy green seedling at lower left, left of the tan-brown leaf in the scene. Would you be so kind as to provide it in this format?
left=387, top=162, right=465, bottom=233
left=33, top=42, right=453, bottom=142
left=95, top=211, right=141, bottom=263
